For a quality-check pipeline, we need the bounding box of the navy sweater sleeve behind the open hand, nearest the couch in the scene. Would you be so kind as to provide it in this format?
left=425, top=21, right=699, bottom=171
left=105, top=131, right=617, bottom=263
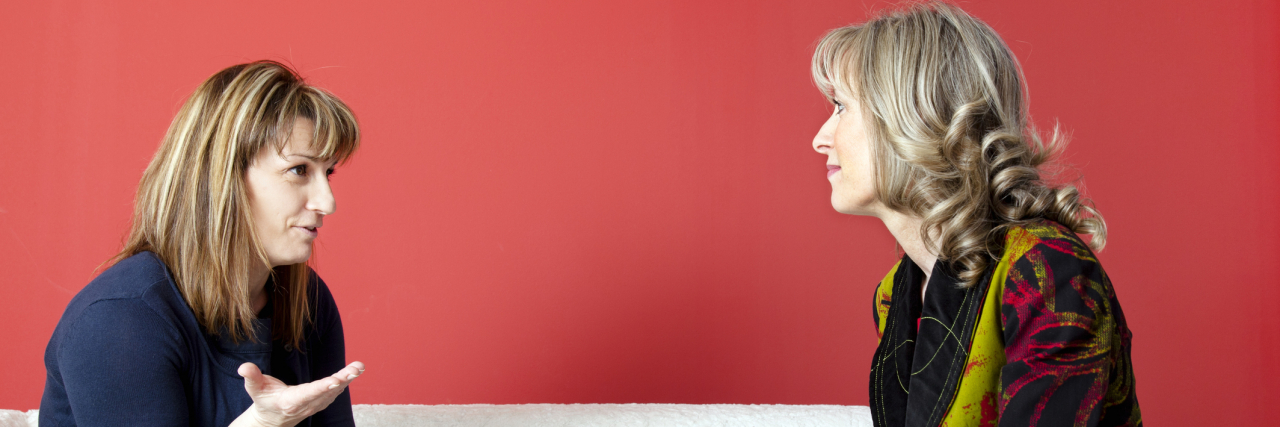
left=308, top=279, right=358, bottom=427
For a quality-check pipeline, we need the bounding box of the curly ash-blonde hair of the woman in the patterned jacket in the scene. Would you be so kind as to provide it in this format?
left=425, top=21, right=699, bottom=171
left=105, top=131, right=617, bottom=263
left=813, top=3, right=1107, bottom=288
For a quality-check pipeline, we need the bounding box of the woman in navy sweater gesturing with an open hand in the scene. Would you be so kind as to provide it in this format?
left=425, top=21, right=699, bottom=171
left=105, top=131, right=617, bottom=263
left=40, top=61, right=365, bottom=426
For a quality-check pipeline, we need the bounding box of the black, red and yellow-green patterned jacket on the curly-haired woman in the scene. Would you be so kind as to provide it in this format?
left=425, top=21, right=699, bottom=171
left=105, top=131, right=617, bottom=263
left=870, top=221, right=1142, bottom=426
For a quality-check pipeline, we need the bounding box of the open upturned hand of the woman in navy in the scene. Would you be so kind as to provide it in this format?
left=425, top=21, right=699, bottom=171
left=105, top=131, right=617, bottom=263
left=233, top=362, right=365, bottom=427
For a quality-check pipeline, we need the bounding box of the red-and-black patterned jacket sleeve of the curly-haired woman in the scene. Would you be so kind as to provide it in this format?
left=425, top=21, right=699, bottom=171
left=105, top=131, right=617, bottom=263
left=1000, top=244, right=1116, bottom=426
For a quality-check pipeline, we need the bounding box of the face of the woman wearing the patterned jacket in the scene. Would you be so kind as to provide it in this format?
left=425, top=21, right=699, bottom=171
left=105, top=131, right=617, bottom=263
left=813, top=93, right=881, bottom=215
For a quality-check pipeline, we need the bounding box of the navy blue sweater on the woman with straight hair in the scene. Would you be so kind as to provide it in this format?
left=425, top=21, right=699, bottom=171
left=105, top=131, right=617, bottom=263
left=40, top=252, right=355, bottom=427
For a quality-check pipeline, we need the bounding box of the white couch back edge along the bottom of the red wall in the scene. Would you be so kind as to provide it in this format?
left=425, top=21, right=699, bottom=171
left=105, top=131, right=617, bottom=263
left=0, top=404, right=872, bottom=427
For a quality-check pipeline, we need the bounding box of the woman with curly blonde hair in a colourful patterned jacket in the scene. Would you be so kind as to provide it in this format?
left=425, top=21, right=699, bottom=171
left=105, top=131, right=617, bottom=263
left=813, top=4, right=1142, bottom=426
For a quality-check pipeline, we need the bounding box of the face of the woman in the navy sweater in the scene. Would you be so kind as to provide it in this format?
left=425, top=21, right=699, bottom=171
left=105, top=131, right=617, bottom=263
left=244, top=119, right=337, bottom=267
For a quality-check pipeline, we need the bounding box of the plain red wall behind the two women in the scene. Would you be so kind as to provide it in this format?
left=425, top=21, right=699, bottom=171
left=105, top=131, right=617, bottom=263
left=0, top=0, right=1280, bottom=426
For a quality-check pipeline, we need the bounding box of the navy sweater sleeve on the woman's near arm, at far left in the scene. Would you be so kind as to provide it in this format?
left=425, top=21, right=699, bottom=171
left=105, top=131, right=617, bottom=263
left=56, top=299, right=189, bottom=426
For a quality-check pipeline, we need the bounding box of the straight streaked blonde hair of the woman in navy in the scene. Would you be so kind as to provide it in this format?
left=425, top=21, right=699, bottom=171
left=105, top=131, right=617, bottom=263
left=113, top=60, right=360, bottom=348
